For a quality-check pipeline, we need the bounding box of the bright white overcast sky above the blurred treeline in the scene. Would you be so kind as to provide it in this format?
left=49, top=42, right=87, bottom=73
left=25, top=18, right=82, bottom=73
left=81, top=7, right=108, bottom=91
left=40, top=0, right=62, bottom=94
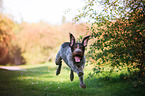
left=3, top=0, right=84, bottom=25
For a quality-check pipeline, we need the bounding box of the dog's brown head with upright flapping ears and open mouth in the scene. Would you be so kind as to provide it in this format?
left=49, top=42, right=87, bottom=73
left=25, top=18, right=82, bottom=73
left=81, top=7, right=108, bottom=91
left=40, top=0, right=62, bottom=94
left=69, top=33, right=90, bottom=63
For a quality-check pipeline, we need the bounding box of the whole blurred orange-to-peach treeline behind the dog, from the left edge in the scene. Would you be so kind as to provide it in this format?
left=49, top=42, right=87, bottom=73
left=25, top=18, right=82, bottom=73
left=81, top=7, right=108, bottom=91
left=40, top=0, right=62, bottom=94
left=0, top=17, right=88, bottom=65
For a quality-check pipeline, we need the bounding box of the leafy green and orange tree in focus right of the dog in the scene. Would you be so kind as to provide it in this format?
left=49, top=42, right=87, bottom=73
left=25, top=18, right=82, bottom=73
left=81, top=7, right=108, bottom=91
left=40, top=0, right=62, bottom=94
left=75, top=0, right=145, bottom=84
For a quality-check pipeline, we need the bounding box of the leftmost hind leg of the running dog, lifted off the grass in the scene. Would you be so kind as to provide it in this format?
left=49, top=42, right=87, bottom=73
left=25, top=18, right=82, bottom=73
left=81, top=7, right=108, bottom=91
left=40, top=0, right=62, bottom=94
left=55, top=51, right=62, bottom=75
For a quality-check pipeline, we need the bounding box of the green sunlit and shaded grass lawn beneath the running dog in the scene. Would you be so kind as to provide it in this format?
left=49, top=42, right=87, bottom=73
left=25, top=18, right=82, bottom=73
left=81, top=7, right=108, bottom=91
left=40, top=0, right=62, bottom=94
left=0, top=63, right=145, bottom=96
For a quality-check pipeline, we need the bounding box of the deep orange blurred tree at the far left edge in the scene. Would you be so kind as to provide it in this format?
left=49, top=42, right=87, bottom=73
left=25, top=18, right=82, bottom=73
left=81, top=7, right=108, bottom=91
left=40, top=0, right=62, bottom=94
left=0, top=14, right=14, bottom=64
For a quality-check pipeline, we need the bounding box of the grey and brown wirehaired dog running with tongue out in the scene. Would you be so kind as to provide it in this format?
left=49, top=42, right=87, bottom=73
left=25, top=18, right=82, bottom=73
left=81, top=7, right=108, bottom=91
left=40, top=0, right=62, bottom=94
left=55, top=33, right=90, bottom=88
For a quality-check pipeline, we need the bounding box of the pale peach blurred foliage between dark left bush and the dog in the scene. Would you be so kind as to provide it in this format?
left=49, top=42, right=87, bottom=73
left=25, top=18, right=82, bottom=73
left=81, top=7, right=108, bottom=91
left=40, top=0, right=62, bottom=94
left=12, top=22, right=87, bottom=64
